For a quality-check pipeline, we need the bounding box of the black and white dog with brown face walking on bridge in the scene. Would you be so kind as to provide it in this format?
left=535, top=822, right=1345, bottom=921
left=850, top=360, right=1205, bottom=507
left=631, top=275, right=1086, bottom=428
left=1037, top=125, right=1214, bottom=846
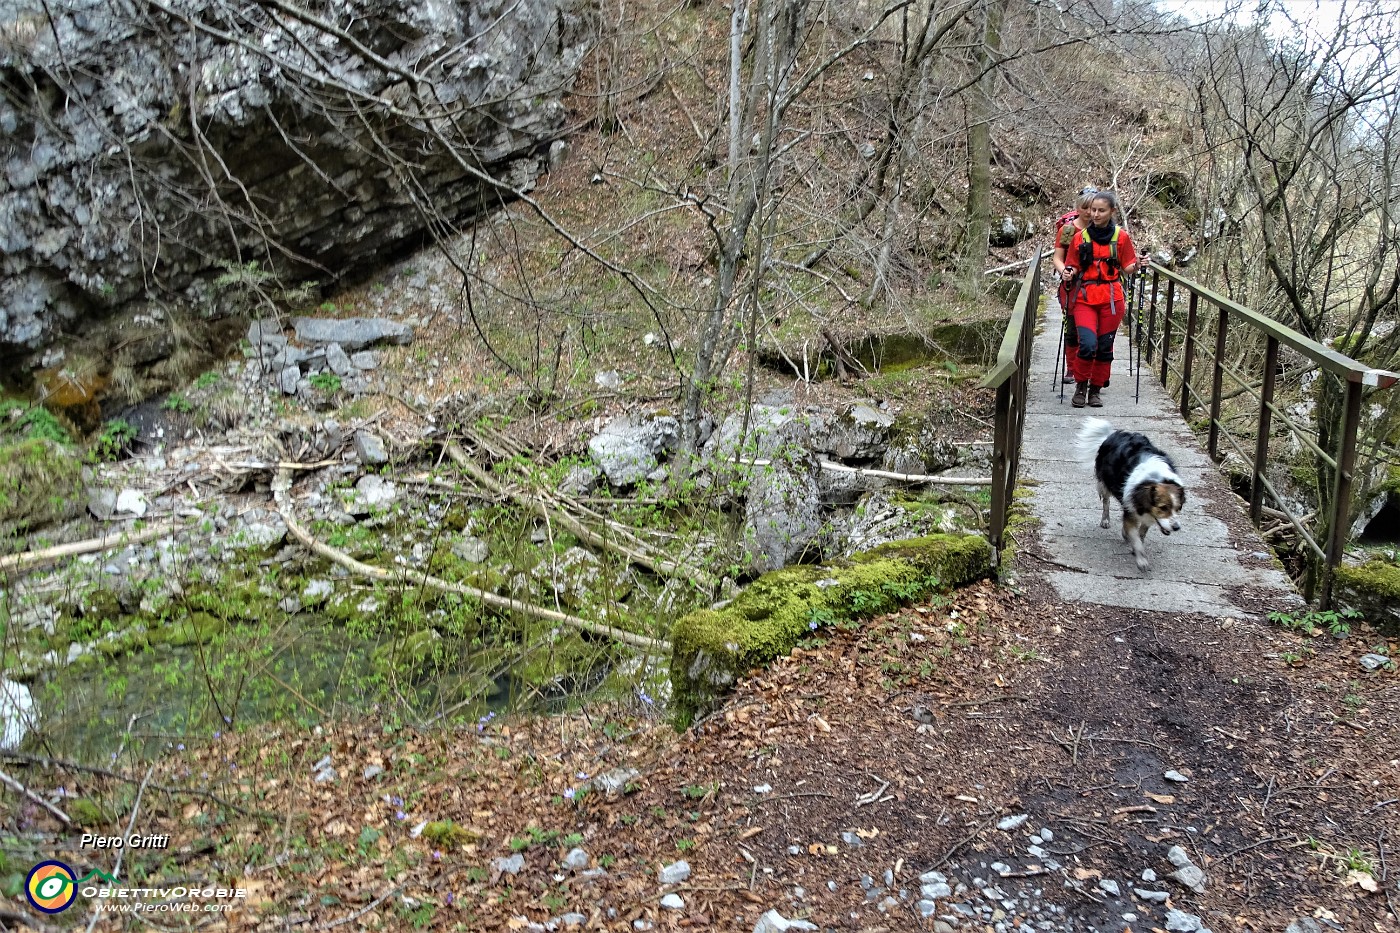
left=1079, top=417, right=1186, bottom=572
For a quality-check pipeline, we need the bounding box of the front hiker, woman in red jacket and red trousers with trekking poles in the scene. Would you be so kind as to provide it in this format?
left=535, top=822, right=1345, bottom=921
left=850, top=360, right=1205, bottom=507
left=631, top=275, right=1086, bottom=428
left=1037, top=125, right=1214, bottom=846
left=1064, top=191, right=1137, bottom=408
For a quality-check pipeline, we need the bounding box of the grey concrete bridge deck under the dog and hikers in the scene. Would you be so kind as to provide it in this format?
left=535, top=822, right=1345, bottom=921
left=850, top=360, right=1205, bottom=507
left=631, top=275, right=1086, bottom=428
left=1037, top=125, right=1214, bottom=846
left=1021, top=296, right=1299, bottom=616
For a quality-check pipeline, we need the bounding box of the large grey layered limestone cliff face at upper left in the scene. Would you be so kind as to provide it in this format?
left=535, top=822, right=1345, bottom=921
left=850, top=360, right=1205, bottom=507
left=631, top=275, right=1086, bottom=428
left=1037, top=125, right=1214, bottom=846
left=0, top=0, right=589, bottom=360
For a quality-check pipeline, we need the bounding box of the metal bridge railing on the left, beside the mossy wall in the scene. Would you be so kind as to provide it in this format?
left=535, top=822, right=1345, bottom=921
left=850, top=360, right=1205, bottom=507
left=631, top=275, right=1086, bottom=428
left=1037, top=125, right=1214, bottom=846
left=981, top=254, right=1044, bottom=560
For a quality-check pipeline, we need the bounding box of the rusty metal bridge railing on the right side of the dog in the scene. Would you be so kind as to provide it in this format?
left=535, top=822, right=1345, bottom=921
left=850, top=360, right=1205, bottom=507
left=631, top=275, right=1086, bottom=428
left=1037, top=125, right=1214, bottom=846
left=1136, top=263, right=1400, bottom=608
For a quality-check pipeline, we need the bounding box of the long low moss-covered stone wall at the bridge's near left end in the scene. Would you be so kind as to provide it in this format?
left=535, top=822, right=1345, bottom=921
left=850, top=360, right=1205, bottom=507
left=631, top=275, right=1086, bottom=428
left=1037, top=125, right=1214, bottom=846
left=671, top=535, right=991, bottom=723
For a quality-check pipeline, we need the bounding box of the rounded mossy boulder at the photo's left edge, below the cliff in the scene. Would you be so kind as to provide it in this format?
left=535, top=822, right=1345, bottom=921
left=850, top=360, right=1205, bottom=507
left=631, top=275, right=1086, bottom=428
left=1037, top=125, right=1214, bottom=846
left=0, top=437, right=84, bottom=538
